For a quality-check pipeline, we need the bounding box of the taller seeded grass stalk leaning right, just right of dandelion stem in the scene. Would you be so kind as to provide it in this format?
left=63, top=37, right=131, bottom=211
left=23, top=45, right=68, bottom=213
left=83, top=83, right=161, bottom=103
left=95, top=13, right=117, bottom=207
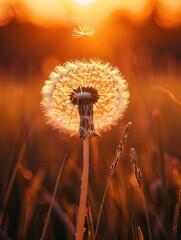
left=95, top=122, right=132, bottom=239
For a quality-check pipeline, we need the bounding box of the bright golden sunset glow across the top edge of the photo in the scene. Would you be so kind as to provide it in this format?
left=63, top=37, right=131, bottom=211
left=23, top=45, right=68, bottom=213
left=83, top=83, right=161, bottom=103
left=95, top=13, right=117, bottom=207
left=0, top=0, right=181, bottom=27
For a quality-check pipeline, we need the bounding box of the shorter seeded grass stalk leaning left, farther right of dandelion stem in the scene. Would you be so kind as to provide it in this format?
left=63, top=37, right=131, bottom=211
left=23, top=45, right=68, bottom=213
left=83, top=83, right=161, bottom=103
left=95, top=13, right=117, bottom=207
left=130, top=148, right=152, bottom=240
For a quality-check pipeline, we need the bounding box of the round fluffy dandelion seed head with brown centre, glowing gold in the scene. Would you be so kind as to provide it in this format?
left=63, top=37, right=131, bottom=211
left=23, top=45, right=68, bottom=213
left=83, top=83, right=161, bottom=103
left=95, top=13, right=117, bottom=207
left=41, top=59, right=129, bottom=137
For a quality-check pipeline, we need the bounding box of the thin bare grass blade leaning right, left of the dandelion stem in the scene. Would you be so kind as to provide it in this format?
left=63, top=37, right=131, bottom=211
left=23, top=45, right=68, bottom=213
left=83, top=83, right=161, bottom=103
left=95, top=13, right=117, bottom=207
left=41, top=153, right=67, bottom=240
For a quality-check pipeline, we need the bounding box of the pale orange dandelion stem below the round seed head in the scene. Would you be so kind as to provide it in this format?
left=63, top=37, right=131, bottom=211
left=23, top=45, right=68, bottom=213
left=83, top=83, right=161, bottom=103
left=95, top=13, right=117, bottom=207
left=76, top=136, right=89, bottom=240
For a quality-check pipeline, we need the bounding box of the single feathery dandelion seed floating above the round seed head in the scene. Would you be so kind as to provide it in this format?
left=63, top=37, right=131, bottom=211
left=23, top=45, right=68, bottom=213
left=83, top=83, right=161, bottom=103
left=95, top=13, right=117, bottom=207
left=73, top=25, right=95, bottom=38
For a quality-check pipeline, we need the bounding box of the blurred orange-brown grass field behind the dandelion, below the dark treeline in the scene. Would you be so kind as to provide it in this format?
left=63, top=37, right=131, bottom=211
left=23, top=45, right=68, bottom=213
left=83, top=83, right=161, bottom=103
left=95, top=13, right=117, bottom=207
left=0, top=16, right=181, bottom=240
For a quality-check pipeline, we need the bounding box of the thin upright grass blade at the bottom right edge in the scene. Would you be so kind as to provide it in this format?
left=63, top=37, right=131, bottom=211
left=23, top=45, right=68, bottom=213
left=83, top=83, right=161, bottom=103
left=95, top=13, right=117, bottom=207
left=172, top=189, right=181, bottom=239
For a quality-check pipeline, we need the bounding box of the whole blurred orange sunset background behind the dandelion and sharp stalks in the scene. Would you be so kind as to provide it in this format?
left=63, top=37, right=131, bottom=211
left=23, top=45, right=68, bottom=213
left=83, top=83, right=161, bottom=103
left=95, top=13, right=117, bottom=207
left=0, top=0, right=181, bottom=240
